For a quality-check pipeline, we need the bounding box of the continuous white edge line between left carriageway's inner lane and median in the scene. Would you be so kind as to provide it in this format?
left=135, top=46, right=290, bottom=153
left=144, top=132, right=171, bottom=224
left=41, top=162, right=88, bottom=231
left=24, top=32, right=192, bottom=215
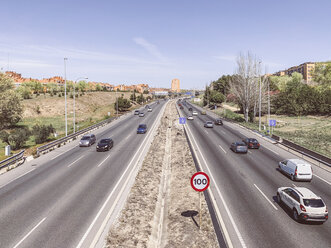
left=76, top=103, right=167, bottom=248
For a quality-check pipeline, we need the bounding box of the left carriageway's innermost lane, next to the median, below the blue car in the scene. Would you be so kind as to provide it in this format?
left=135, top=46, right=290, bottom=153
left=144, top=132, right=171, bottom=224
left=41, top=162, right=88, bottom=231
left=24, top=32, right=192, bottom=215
left=16, top=105, right=165, bottom=247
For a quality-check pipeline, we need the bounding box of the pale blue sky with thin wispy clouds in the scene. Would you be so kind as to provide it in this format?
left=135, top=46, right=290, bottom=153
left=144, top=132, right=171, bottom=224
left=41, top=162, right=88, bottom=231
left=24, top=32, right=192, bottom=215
left=0, top=0, right=331, bottom=89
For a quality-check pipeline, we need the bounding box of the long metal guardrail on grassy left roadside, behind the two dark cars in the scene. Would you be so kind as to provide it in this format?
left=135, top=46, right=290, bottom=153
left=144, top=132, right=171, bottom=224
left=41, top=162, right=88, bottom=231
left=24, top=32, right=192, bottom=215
left=37, top=117, right=117, bottom=156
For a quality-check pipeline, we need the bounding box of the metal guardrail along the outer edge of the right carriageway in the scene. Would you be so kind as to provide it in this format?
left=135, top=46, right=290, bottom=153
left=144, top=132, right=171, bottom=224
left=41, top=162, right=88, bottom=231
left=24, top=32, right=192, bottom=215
left=188, top=103, right=331, bottom=167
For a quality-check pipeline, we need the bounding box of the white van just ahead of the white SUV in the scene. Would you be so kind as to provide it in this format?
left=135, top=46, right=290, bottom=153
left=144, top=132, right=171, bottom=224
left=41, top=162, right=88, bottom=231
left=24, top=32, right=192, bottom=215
left=278, top=159, right=313, bottom=182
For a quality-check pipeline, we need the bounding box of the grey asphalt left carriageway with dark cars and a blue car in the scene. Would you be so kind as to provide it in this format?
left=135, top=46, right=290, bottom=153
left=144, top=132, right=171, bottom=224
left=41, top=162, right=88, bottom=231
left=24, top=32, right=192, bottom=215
left=0, top=100, right=166, bottom=248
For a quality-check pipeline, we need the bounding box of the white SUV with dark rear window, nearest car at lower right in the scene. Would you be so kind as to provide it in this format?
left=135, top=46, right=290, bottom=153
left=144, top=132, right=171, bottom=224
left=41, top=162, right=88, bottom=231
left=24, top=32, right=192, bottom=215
left=277, top=187, right=329, bottom=222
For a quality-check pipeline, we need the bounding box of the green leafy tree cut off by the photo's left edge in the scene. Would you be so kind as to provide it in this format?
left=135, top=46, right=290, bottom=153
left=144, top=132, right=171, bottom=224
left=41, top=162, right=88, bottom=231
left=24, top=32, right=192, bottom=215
left=0, top=74, right=23, bottom=130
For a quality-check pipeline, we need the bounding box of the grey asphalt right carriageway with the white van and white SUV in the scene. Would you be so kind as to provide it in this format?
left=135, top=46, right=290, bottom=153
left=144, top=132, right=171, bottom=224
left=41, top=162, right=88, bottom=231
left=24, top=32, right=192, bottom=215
left=180, top=101, right=331, bottom=248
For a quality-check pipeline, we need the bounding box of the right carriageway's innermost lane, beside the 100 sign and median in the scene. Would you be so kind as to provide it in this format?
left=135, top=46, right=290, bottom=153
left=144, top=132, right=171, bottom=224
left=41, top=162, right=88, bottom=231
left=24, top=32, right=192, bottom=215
left=184, top=118, right=294, bottom=247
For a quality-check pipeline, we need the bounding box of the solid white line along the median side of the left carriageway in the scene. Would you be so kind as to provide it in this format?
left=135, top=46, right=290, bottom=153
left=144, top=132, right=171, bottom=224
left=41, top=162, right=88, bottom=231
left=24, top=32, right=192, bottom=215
left=76, top=100, right=166, bottom=248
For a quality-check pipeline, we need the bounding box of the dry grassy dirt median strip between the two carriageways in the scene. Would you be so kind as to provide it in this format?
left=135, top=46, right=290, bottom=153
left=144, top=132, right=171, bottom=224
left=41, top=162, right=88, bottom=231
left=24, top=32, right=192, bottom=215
left=107, top=102, right=218, bottom=248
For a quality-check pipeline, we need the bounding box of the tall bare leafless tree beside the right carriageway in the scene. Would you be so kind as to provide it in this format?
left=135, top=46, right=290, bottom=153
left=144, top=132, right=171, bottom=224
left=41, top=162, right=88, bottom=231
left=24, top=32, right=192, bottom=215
left=230, top=53, right=266, bottom=122
